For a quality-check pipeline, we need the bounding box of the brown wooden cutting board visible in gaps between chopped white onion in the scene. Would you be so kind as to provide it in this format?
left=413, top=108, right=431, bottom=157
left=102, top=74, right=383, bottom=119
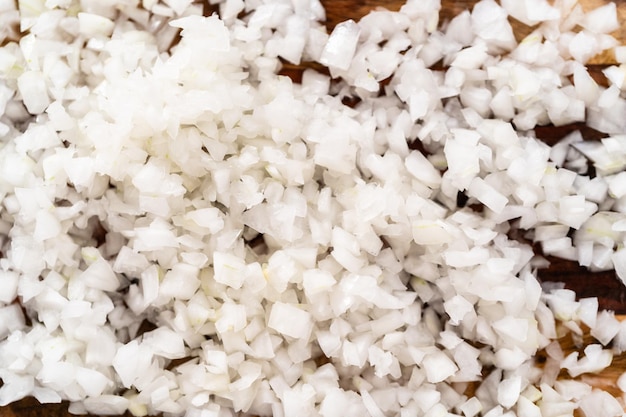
left=0, top=0, right=626, bottom=417
